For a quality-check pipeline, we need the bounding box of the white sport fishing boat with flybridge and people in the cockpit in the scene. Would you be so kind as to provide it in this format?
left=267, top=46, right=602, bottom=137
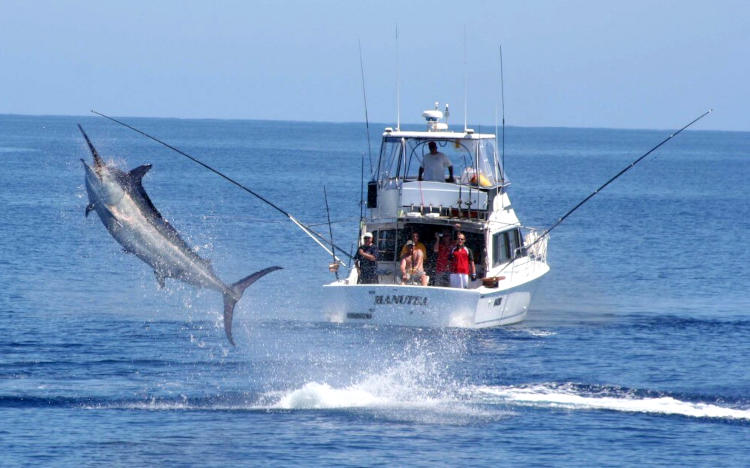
left=323, top=103, right=549, bottom=328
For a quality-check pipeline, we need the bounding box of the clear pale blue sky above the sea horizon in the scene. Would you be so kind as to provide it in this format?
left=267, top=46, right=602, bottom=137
left=0, top=0, right=750, bottom=131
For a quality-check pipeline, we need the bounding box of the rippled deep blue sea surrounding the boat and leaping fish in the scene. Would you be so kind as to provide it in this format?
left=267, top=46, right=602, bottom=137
left=0, top=115, right=750, bottom=466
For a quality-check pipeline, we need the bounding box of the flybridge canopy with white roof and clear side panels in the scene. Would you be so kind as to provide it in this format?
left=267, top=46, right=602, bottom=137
left=373, top=129, right=506, bottom=188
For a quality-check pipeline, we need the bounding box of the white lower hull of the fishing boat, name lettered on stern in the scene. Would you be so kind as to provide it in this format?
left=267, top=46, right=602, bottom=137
left=323, top=265, right=548, bottom=328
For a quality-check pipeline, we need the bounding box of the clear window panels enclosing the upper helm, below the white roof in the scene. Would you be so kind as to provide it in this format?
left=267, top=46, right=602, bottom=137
left=376, top=137, right=502, bottom=187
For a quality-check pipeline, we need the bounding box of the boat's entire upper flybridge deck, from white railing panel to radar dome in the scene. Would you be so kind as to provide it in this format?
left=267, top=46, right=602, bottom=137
left=367, top=103, right=511, bottom=221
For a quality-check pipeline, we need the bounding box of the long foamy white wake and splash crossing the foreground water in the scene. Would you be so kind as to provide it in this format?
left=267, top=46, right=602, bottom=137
left=8, top=380, right=750, bottom=424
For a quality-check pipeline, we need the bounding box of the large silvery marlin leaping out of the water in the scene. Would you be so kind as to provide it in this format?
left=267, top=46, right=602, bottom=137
left=78, top=125, right=281, bottom=345
